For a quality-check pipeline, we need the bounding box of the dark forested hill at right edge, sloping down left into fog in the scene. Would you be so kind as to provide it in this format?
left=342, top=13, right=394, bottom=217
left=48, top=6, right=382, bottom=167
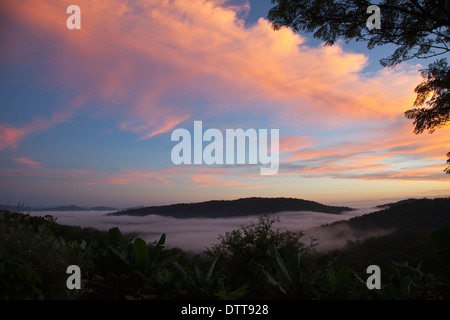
left=329, top=198, right=450, bottom=231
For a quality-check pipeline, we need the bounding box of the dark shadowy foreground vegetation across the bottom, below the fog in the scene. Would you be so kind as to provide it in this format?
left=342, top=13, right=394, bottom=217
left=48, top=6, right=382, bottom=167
left=0, top=200, right=450, bottom=300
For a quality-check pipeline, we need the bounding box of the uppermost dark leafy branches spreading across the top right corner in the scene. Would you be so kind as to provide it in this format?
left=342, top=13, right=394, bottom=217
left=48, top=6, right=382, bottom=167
left=268, top=0, right=450, bottom=67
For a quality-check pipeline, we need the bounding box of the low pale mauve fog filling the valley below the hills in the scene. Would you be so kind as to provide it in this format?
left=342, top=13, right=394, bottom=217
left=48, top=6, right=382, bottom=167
left=30, top=208, right=391, bottom=253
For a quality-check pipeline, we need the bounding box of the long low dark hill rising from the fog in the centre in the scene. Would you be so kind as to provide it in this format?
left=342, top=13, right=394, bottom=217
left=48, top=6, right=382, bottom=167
left=110, top=198, right=353, bottom=218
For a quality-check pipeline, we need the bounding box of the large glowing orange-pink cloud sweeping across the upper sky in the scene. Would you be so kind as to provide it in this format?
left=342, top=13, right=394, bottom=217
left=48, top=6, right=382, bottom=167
left=1, top=0, right=418, bottom=137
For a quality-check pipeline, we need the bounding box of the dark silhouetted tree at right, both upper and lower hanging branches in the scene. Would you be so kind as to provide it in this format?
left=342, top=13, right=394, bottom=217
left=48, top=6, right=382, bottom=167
left=268, top=0, right=450, bottom=174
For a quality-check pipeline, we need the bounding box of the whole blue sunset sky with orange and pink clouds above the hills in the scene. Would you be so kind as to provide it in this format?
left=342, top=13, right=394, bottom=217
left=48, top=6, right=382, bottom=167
left=0, top=0, right=450, bottom=208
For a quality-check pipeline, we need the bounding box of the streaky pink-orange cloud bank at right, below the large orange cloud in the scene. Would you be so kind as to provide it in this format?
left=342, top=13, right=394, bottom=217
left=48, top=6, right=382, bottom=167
left=280, top=123, right=450, bottom=181
